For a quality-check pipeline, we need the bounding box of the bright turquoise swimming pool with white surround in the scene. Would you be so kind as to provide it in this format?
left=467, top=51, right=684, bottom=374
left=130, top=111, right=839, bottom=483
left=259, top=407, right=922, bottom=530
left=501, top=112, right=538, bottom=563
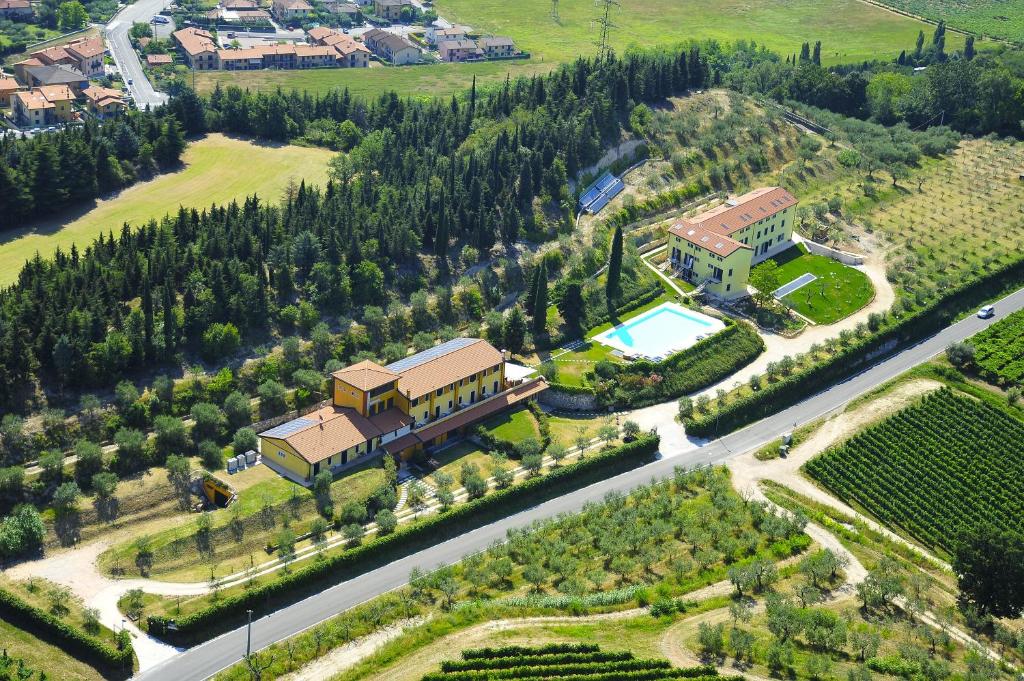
left=594, top=303, right=725, bottom=359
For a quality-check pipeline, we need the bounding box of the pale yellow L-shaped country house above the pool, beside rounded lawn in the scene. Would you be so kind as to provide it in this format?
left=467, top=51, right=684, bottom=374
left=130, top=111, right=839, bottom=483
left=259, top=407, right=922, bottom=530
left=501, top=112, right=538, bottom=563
left=669, top=186, right=797, bottom=300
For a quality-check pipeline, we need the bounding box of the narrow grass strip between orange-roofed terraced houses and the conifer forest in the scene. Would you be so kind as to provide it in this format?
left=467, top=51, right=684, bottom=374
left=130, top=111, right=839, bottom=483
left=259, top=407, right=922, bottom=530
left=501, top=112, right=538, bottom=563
left=196, top=59, right=556, bottom=98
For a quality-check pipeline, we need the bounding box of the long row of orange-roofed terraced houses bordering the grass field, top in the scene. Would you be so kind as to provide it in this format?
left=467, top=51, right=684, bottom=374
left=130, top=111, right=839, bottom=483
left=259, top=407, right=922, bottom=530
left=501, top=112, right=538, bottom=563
left=174, top=27, right=370, bottom=71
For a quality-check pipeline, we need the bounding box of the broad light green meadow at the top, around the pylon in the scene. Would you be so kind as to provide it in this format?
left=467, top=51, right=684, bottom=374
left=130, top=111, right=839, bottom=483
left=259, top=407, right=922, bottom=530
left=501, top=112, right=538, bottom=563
left=435, top=0, right=963, bottom=63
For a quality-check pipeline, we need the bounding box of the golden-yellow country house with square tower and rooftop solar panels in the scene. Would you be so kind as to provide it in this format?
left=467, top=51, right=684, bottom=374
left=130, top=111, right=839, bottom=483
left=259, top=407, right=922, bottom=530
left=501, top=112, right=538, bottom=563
left=260, top=338, right=547, bottom=484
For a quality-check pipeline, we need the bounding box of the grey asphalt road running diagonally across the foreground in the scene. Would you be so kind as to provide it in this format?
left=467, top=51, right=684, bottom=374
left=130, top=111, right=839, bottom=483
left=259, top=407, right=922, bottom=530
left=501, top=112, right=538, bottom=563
left=138, top=289, right=1024, bottom=681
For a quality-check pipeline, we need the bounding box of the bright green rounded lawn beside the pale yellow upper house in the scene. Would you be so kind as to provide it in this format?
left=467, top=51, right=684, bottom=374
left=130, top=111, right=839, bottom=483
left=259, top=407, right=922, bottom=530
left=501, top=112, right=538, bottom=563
left=773, top=246, right=874, bottom=324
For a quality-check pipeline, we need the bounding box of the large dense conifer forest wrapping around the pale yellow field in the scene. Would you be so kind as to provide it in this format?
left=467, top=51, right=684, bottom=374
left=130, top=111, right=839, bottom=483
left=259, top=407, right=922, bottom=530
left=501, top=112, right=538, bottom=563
left=0, top=48, right=707, bottom=405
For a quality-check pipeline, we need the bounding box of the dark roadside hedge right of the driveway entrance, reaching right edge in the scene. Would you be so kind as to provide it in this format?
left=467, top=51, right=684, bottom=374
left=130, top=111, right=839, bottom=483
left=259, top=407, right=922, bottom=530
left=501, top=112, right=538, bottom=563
left=685, top=254, right=1024, bottom=437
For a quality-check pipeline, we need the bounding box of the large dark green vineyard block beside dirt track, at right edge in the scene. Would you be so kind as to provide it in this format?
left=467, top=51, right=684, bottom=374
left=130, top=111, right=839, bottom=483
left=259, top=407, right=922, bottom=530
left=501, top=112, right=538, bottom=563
left=807, top=389, right=1024, bottom=550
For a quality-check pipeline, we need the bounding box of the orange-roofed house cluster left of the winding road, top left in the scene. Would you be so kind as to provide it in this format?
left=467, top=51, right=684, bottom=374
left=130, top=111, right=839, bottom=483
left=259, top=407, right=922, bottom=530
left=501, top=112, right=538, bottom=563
left=0, top=37, right=128, bottom=128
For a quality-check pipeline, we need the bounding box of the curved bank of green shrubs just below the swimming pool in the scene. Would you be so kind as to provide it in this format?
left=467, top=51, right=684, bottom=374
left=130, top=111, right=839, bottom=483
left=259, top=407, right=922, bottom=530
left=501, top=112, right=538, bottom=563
left=597, top=321, right=765, bottom=409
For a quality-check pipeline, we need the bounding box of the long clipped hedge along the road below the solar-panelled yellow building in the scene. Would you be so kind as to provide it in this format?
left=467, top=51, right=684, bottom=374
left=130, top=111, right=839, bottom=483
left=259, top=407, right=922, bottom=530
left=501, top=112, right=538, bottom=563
left=147, top=433, right=659, bottom=643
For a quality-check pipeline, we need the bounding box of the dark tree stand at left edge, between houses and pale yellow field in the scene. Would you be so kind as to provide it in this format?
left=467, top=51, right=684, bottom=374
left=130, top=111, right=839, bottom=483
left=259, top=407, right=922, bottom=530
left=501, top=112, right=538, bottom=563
left=0, top=112, right=185, bottom=227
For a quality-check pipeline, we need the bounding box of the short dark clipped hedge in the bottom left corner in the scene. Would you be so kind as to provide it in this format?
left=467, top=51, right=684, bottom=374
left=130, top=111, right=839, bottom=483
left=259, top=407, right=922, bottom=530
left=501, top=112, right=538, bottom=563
left=0, top=589, right=134, bottom=677
